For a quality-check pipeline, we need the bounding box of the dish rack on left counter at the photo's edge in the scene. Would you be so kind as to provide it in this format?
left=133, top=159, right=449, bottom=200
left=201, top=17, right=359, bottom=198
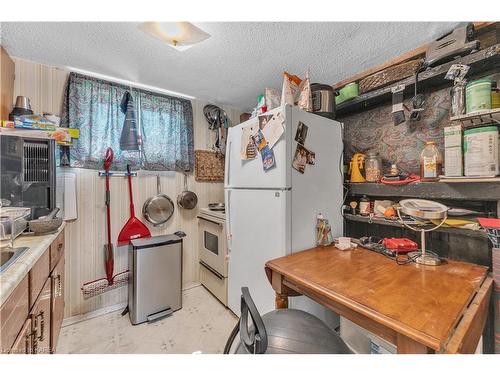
left=0, top=207, right=31, bottom=247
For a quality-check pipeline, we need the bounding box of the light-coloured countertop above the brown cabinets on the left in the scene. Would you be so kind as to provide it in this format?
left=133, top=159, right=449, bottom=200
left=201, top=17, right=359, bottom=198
left=0, top=222, right=66, bottom=306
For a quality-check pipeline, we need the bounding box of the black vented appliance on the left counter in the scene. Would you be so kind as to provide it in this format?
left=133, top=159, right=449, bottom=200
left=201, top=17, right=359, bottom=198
left=0, top=134, right=56, bottom=219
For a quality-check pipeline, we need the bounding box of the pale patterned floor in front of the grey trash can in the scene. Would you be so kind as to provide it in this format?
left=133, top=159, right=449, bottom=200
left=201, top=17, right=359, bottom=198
left=57, top=286, right=237, bottom=354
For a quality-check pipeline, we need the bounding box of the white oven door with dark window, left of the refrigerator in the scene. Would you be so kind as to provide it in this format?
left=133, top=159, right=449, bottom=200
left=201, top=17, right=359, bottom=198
left=198, top=216, right=227, bottom=278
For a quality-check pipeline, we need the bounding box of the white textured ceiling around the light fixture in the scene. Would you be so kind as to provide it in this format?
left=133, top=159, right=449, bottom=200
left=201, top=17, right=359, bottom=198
left=0, top=22, right=457, bottom=110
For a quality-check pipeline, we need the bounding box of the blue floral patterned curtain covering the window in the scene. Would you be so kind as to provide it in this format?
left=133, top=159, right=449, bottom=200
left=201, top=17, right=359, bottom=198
left=61, top=72, right=194, bottom=171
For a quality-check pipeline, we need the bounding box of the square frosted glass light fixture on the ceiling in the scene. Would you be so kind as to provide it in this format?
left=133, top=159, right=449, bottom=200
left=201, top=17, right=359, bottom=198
left=137, top=22, right=210, bottom=51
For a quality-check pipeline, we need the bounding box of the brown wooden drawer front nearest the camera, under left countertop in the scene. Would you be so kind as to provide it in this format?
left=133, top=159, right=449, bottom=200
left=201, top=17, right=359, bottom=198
left=0, top=276, right=29, bottom=353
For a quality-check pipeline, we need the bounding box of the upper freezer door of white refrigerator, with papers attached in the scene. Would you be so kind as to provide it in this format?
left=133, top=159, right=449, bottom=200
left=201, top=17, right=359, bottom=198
left=224, top=106, right=291, bottom=189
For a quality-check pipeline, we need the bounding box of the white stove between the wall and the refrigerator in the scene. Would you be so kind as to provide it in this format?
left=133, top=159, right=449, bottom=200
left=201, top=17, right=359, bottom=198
left=198, top=208, right=228, bottom=306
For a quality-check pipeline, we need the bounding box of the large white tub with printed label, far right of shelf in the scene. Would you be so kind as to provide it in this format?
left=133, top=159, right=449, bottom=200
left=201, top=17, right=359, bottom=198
left=464, top=125, right=498, bottom=177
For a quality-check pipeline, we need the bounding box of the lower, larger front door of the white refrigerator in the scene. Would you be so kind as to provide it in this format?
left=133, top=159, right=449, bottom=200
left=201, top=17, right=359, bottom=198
left=226, top=189, right=291, bottom=316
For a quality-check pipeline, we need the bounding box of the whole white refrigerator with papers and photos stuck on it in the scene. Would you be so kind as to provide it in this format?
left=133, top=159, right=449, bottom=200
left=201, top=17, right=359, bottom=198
left=224, top=105, right=343, bottom=325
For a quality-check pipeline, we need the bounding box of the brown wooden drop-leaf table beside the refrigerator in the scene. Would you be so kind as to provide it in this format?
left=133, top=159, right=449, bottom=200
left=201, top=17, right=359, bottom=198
left=266, top=246, right=492, bottom=353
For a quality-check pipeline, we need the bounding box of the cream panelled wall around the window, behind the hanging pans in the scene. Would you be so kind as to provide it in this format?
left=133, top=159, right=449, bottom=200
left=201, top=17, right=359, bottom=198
left=14, top=59, right=241, bottom=318
